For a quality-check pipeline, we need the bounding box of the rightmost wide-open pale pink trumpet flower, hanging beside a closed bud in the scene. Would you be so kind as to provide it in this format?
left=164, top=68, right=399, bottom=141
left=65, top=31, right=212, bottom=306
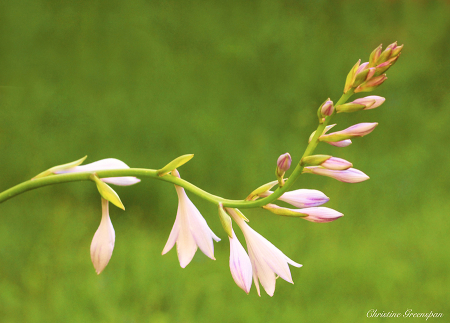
left=227, top=208, right=302, bottom=296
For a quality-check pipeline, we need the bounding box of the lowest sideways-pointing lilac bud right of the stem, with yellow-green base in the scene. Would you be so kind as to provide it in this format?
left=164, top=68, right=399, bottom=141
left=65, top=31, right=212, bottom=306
left=263, top=203, right=343, bottom=223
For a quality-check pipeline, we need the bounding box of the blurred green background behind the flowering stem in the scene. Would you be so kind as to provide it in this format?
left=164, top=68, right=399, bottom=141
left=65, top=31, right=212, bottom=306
left=0, top=0, right=450, bottom=323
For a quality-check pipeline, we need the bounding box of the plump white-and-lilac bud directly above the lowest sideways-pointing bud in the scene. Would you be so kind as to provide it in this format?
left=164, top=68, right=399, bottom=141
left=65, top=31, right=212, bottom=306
left=259, top=189, right=330, bottom=208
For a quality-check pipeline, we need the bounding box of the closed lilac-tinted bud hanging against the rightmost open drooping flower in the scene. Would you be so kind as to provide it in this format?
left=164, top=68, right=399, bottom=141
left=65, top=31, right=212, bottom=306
left=228, top=231, right=252, bottom=294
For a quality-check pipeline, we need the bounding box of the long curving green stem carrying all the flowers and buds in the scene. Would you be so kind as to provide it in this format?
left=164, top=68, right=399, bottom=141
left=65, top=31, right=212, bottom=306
left=0, top=90, right=353, bottom=209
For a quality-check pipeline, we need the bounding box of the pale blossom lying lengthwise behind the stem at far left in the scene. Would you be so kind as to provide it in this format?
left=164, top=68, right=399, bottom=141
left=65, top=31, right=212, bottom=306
left=56, top=158, right=141, bottom=186
